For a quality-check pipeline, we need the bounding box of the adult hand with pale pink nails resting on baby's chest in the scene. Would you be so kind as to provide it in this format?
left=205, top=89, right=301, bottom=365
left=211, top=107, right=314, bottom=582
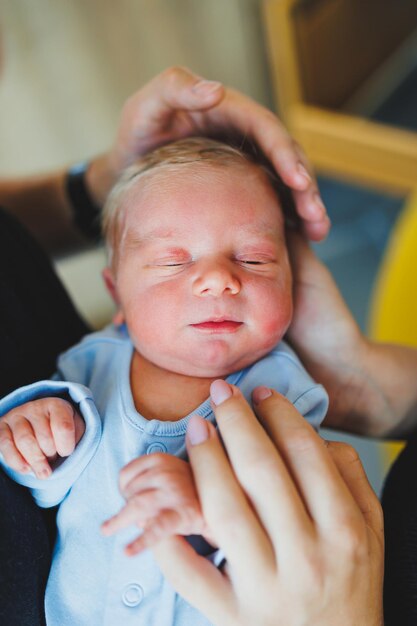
left=154, top=381, right=383, bottom=626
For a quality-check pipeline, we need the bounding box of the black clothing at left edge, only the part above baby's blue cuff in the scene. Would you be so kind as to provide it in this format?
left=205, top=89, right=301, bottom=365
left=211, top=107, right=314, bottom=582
left=0, top=209, right=89, bottom=397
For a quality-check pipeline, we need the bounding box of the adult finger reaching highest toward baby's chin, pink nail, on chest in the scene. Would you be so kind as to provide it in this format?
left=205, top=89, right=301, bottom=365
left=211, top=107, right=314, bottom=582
left=211, top=381, right=313, bottom=550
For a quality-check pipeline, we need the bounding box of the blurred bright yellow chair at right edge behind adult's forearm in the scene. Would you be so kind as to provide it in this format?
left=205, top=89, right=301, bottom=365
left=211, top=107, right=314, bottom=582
left=369, top=190, right=417, bottom=471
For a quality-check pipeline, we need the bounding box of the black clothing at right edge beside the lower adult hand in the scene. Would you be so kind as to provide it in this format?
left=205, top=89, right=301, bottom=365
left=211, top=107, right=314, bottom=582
left=382, top=435, right=417, bottom=626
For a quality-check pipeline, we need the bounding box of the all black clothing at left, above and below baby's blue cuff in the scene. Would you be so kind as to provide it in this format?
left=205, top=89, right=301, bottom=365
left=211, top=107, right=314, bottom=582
left=0, top=209, right=89, bottom=626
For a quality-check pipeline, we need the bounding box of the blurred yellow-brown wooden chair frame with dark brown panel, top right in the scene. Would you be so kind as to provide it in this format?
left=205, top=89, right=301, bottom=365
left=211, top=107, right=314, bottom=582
left=261, top=0, right=417, bottom=194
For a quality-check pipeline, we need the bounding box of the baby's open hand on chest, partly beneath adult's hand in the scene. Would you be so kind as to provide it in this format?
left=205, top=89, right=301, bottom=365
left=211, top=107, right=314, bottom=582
left=102, top=453, right=207, bottom=556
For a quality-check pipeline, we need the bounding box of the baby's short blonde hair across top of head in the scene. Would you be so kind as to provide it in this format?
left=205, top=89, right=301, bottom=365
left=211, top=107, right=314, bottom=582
left=102, top=137, right=288, bottom=263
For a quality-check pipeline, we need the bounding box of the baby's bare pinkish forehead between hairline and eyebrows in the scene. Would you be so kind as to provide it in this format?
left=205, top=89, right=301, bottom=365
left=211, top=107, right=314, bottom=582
left=118, top=164, right=284, bottom=242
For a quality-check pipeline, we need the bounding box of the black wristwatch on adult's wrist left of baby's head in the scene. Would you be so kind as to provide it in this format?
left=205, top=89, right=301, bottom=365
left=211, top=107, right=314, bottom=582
left=65, top=161, right=101, bottom=240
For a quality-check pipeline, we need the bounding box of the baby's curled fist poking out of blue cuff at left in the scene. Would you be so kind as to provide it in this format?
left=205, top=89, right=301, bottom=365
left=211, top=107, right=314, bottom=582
left=0, top=398, right=85, bottom=478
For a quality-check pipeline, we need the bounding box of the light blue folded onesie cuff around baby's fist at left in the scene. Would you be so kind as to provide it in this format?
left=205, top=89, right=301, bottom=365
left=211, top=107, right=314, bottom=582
left=0, top=380, right=102, bottom=508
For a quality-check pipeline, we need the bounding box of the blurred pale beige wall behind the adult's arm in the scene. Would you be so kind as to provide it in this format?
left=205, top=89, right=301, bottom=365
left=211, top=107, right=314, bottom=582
left=0, top=0, right=270, bottom=326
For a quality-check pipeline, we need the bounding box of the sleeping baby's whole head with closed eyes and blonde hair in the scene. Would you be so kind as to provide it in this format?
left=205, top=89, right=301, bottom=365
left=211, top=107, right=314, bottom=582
left=103, top=138, right=292, bottom=378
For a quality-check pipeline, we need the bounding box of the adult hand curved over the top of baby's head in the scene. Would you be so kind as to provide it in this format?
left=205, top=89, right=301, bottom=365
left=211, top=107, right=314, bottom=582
left=87, top=67, right=329, bottom=240
